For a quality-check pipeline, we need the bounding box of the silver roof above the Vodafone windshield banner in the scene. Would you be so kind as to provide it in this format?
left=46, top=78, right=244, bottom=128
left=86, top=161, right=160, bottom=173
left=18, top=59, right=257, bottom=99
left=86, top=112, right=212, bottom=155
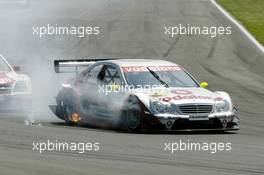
left=107, top=59, right=178, bottom=67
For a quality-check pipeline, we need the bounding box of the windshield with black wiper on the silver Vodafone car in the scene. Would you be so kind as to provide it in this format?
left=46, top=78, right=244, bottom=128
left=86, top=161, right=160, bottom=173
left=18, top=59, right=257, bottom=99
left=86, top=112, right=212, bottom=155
left=123, top=66, right=199, bottom=87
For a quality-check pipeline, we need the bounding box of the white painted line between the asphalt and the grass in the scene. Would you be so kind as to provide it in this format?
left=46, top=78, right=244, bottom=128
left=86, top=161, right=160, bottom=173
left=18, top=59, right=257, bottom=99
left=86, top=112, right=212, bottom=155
left=211, top=0, right=264, bottom=53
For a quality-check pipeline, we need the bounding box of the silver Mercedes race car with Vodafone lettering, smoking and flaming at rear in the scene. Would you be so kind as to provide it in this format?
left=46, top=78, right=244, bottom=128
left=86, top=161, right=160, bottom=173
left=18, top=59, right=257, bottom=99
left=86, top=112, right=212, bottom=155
left=50, top=59, right=239, bottom=132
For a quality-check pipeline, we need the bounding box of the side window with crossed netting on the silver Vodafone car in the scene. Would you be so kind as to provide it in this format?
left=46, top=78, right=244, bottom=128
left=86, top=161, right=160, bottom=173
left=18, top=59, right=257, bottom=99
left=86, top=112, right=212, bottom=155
left=98, top=65, right=123, bottom=85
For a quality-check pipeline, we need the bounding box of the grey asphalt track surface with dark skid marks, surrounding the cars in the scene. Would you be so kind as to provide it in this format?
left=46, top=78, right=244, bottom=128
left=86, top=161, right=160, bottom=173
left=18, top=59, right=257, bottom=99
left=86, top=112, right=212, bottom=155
left=0, top=0, right=264, bottom=175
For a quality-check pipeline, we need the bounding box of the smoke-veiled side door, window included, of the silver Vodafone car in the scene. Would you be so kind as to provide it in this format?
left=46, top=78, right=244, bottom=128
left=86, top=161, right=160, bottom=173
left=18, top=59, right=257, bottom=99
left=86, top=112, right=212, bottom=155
left=78, top=64, right=124, bottom=121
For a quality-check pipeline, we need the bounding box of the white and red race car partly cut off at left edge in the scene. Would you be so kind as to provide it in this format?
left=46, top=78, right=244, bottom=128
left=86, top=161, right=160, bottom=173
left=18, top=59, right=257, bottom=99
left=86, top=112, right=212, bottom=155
left=0, top=55, right=32, bottom=113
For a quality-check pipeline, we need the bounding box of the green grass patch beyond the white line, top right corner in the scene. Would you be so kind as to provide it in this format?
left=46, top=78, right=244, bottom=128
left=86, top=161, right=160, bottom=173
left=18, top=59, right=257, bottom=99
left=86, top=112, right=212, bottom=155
left=217, top=0, right=264, bottom=45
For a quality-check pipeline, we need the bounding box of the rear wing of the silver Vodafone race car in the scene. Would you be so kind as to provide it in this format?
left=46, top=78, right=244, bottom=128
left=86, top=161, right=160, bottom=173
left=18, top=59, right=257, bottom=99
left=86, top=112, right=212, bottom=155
left=54, top=58, right=113, bottom=74
